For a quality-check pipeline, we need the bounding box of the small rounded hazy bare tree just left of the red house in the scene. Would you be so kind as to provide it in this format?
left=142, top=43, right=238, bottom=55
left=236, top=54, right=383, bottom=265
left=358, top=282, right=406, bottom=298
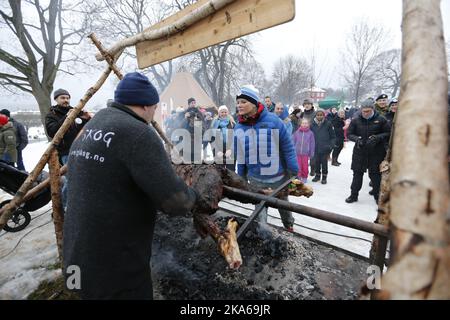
left=272, top=55, right=312, bottom=104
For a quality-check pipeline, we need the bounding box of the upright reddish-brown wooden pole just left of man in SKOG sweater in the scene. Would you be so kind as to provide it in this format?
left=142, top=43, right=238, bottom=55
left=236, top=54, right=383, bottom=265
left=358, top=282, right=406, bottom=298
left=48, top=150, right=64, bottom=269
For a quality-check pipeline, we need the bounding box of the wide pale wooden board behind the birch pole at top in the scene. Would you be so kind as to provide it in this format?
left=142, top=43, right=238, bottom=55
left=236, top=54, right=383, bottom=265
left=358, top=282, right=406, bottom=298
left=136, top=0, right=295, bottom=69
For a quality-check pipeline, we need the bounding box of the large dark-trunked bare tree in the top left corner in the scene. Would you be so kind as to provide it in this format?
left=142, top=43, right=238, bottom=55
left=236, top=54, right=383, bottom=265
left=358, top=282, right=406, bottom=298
left=0, top=0, right=94, bottom=122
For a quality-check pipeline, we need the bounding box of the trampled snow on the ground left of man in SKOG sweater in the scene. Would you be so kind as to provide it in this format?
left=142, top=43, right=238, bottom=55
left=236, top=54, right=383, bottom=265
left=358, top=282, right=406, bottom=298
left=0, top=142, right=61, bottom=300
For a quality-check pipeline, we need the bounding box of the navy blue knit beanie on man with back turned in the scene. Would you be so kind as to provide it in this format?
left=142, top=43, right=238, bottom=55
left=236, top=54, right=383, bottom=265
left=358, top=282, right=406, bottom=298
left=114, top=72, right=159, bottom=106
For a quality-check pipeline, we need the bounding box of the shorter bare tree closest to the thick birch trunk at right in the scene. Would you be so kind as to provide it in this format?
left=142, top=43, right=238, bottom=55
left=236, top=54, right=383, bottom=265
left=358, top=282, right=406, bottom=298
left=370, top=49, right=401, bottom=97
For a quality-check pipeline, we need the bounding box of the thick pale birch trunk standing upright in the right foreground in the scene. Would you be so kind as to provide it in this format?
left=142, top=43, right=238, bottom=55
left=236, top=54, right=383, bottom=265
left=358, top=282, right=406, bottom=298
left=377, top=0, right=450, bottom=299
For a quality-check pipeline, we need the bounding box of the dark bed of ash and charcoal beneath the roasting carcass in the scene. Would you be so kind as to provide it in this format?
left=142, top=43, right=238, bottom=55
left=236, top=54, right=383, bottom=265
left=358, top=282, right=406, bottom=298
left=152, top=212, right=369, bottom=300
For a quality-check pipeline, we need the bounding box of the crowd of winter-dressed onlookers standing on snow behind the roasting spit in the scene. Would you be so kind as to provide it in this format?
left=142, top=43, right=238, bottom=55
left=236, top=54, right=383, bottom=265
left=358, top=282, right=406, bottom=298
left=165, top=86, right=398, bottom=204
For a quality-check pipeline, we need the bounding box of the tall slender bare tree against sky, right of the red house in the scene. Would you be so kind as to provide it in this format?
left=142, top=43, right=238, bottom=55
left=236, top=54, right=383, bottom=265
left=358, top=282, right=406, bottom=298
left=341, top=20, right=387, bottom=105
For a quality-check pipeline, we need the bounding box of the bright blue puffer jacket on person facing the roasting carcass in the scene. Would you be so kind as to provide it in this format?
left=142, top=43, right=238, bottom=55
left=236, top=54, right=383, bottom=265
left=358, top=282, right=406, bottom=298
left=234, top=108, right=298, bottom=181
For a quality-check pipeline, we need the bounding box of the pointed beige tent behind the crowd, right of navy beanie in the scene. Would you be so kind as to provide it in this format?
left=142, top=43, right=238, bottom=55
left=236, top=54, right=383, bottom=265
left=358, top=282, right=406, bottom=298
left=154, top=72, right=216, bottom=125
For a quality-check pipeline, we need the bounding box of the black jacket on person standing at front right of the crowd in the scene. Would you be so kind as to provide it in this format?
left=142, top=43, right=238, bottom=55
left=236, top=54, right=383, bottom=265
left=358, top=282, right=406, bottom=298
left=347, top=112, right=391, bottom=172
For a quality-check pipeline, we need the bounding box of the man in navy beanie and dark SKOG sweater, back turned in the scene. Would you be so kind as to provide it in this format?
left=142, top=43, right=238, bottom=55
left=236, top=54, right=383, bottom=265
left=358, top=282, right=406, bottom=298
left=63, top=72, right=197, bottom=299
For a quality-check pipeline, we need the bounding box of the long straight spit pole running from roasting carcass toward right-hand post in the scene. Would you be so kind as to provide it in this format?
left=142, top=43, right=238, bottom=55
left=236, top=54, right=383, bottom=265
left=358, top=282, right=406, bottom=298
left=223, top=186, right=389, bottom=237
